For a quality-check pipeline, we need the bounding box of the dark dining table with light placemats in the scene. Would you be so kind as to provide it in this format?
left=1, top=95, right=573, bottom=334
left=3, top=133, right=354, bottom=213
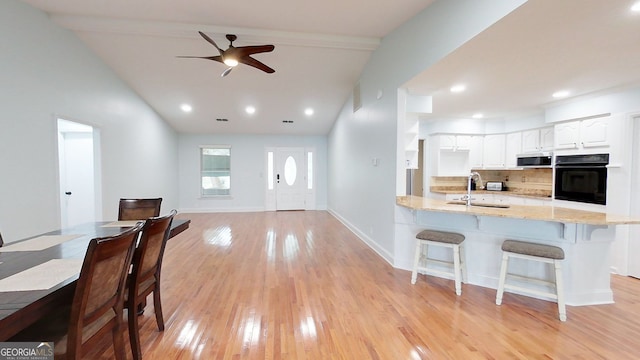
left=0, top=218, right=191, bottom=342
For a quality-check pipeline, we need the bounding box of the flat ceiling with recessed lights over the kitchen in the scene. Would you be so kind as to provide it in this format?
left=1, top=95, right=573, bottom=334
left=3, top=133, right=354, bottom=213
left=406, top=0, right=640, bottom=119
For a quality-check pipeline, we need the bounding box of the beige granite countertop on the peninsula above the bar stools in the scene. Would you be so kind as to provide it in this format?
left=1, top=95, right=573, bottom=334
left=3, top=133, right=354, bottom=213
left=396, top=196, right=640, bottom=225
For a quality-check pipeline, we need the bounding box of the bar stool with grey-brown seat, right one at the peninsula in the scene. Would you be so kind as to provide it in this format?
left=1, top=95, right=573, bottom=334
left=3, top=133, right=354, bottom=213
left=496, top=240, right=567, bottom=321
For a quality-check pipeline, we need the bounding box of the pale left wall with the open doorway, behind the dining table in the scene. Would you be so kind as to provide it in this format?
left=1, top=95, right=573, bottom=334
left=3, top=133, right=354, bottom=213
left=0, top=0, right=178, bottom=241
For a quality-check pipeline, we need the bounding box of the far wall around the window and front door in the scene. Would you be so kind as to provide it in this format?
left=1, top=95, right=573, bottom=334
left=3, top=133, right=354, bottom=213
left=178, top=134, right=327, bottom=212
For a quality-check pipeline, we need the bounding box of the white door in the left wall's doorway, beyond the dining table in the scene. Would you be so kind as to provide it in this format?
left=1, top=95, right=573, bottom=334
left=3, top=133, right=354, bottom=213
left=58, top=119, right=96, bottom=228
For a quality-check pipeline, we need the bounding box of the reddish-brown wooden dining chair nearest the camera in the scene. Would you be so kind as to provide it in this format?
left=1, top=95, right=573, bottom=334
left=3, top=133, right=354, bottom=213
left=10, top=223, right=143, bottom=360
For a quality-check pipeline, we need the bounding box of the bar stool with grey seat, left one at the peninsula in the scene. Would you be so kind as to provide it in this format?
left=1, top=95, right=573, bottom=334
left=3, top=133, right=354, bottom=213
left=411, top=230, right=466, bottom=295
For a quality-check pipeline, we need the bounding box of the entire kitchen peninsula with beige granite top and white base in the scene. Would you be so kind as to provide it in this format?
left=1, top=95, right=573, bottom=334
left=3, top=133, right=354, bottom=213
left=396, top=196, right=640, bottom=306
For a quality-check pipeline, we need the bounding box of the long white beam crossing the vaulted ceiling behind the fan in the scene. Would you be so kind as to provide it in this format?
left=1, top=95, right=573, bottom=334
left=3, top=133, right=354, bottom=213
left=50, top=15, right=380, bottom=51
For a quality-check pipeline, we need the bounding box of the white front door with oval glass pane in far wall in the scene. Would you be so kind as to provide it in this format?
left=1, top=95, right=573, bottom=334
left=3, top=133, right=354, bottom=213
left=274, top=148, right=306, bottom=210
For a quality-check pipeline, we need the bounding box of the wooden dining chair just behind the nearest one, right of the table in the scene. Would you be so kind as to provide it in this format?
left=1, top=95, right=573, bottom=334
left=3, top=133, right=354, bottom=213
left=126, top=210, right=177, bottom=360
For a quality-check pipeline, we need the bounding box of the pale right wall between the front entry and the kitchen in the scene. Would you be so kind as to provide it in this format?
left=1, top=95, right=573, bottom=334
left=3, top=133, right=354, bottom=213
left=328, top=0, right=525, bottom=263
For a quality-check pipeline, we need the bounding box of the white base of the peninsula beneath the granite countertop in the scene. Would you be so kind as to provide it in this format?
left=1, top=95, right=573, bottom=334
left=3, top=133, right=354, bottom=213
left=394, top=197, right=628, bottom=306
